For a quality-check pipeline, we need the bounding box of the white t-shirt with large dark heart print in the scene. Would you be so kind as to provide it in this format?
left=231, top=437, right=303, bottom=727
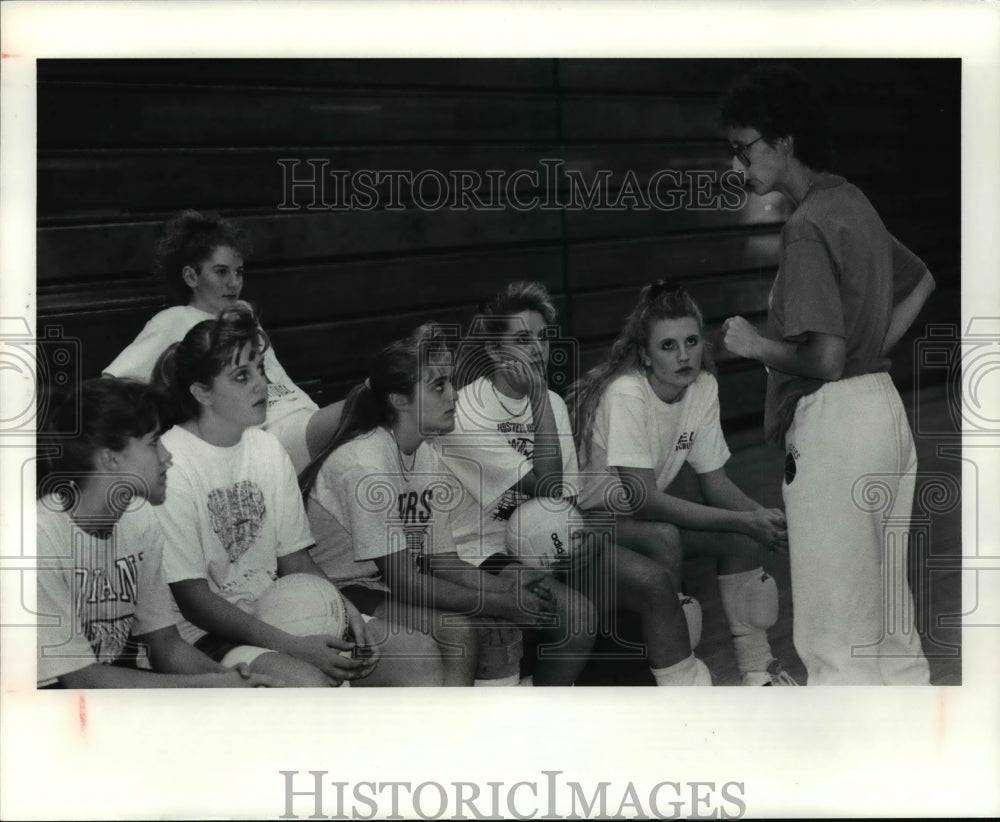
left=156, top=426, right=313, bottom=642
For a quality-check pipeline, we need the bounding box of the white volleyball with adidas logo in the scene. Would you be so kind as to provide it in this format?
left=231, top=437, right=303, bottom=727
left=505, top=497, right=586, bottom=568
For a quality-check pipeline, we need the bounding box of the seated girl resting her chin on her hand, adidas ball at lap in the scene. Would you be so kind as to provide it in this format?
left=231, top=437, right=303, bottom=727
left=436, top=282, right=711, bottom=685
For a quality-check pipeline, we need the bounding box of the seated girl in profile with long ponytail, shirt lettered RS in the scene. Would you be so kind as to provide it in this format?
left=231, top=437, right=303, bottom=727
left=301, top=325, right=532, bottom=685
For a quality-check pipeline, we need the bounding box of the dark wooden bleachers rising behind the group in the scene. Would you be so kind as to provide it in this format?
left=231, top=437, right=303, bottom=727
left=37, top=59, right=961, bottom=442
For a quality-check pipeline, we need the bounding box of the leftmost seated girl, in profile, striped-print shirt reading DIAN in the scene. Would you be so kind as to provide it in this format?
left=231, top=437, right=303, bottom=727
left=37, top=378, right=280, bottom=688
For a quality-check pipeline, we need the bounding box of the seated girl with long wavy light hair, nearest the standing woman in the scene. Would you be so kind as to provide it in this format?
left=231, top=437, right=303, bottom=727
left=569, top=280, right=797, bottom=685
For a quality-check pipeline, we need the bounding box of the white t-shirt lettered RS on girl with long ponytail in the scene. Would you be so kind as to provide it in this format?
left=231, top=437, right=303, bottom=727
left=306, top=427, right=461, bottom=590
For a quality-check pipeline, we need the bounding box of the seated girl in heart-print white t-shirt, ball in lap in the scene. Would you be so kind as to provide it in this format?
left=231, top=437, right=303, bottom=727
left=153, top=303, right=442, bottom=685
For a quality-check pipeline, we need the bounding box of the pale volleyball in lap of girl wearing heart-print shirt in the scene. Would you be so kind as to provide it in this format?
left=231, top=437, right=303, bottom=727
left=254, top=574, right=347, bottom=639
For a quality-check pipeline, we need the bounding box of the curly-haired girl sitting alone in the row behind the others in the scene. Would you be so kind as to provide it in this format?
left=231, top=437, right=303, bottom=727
left=104, top=210, right=343, bottom=472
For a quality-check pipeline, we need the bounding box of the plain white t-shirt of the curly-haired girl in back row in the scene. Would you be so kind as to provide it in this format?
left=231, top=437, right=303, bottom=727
left=104, top=305, right=319, bottom=439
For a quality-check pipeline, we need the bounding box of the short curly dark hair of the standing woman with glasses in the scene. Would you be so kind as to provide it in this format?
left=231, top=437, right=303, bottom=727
left=719, top=64, right=834, bottom=171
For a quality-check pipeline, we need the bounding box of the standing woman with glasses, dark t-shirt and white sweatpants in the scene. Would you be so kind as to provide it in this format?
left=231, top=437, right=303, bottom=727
left=721, top=66, right=935, bottom=685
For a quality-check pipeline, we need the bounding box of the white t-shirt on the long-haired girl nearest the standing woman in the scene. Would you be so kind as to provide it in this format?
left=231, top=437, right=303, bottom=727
left=579, top=371, right=730, bottom=509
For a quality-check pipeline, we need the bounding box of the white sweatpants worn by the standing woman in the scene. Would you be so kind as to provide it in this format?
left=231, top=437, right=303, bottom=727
left=782, top=373, right=930, bottom=685
